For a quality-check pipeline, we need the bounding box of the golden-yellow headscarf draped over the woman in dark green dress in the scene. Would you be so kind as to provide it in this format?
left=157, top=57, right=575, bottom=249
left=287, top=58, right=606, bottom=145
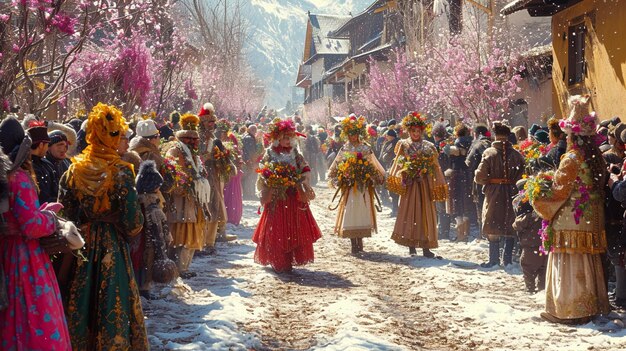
left=68, top=103, right=134, bottom=213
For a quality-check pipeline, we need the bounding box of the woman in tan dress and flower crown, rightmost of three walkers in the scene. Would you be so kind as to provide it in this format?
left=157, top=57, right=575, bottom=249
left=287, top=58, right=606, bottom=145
left=388, top=112, right=448, bottom=258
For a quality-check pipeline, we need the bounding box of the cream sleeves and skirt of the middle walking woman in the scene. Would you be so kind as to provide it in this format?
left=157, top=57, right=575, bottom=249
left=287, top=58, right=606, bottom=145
left=328, top=143, right=385, bottom=239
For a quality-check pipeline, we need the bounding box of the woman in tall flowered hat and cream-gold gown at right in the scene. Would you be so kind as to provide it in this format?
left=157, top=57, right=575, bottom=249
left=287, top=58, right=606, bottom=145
left=531, top=95, right=609, bottom=324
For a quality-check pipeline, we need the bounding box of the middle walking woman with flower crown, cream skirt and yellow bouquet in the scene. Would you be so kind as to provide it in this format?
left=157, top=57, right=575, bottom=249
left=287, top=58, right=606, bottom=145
left=328, top=114, right=385, bottom=254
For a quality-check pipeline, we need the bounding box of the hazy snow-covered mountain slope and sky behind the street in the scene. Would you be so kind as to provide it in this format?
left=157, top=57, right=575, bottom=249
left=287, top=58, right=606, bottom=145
left=246, top=0, right=374, bottom=108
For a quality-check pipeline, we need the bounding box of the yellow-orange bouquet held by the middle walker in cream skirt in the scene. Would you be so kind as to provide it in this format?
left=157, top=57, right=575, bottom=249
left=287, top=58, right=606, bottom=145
left=337, top=152, right=382, bottom=191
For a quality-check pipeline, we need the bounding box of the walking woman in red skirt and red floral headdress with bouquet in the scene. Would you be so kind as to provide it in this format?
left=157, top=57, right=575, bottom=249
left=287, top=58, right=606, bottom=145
left=252, top=118, right=322, bottom=273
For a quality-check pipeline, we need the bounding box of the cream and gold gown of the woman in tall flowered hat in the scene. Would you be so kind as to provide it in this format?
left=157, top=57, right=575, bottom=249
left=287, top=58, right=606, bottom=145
left=533, top=151, right=609, bottom=319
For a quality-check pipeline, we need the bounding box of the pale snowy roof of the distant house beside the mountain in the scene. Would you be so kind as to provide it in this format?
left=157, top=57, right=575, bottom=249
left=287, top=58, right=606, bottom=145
left=309, top=14, right=352, bottom=55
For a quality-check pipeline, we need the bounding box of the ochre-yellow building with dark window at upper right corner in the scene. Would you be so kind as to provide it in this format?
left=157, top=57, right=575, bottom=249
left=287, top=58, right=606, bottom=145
left=502, top=0, right=626, bottom=119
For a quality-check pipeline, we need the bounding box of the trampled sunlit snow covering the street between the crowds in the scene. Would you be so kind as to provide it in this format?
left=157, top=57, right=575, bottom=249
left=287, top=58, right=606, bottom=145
left=143, top=185, right=626, bottom=351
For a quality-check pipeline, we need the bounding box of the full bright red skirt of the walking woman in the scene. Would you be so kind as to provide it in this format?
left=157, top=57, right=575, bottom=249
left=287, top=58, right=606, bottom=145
left=252, top=192, right=322, bottom=272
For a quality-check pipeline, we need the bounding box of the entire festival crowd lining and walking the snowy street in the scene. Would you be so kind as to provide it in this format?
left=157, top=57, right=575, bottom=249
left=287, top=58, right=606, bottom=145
left=0, top=96, right=626, bottom=350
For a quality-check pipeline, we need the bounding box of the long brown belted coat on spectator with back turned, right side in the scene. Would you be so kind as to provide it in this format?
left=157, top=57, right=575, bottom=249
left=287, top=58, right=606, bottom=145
left=474, top=141, right=524, bottom=240
